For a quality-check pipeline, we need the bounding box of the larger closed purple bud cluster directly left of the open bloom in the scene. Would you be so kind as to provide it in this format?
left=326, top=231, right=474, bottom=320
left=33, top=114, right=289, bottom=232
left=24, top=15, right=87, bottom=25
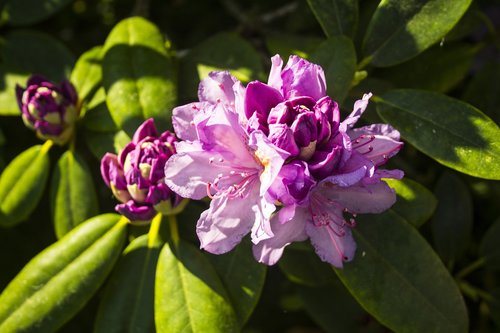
left=101, top=119, right=182, bottom=221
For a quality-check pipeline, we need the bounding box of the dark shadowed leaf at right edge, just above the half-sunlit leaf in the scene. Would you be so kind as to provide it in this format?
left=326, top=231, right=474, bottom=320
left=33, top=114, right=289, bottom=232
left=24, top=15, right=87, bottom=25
left=463, top=61, right=500, bottom=124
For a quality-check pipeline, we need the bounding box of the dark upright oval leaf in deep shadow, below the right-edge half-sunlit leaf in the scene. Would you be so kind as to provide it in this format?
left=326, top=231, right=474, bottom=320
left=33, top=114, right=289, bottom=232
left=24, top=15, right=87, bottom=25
left=431, top=172, right=474, bottom=263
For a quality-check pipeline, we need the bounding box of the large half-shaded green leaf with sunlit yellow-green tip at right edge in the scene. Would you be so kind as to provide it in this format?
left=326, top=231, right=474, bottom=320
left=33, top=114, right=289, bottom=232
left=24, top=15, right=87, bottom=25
left=376, top=89, right=500, bottom=179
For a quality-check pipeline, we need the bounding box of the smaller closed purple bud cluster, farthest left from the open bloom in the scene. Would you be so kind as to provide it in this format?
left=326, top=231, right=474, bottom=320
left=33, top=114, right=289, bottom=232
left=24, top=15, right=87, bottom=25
left=16, top=75, right=79, bottom=145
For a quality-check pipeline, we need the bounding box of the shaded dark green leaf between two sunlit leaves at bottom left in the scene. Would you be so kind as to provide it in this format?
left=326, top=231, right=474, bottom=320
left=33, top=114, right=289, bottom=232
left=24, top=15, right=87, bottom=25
left=94, top=235, right=162, bottom=333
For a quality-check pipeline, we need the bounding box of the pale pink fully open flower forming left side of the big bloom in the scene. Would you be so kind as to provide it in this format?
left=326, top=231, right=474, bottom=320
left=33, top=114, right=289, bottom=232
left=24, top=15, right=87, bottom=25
left=165, top=97, right=288, bottom=254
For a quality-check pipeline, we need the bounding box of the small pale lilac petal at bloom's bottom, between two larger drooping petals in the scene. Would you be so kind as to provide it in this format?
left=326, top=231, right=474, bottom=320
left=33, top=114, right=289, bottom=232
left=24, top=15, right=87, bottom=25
left=253, top=206, right=310, bottom=265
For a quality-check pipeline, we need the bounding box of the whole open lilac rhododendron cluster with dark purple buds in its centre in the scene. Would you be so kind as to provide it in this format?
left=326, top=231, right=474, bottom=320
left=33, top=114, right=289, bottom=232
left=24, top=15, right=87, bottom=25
left=165, top=56, right=403, bottom=267
